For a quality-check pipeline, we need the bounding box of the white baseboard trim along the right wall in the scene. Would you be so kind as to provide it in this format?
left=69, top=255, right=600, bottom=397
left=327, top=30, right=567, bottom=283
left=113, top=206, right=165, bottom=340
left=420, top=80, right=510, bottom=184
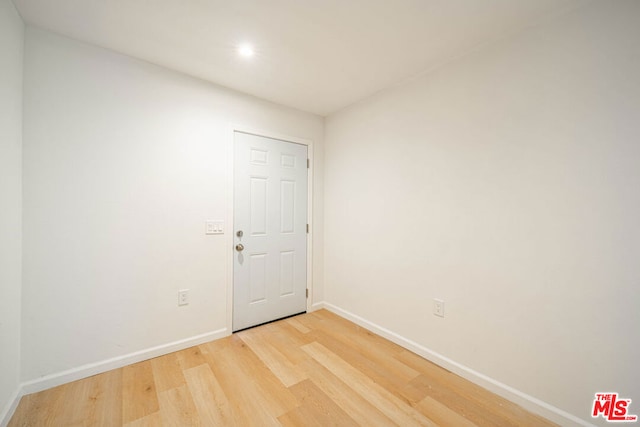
left=322, top=302, right=594, bottom=427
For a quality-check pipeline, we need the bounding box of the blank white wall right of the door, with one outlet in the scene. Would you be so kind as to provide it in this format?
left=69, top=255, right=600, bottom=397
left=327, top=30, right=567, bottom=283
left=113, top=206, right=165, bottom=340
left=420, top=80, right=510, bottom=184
left=325, top=1, right=640, bottom=423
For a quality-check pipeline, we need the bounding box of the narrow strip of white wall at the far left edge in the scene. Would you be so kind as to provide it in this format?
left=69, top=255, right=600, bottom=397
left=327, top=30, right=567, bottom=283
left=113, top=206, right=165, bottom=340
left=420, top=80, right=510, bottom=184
left=0, top=0, right=24, bottom=423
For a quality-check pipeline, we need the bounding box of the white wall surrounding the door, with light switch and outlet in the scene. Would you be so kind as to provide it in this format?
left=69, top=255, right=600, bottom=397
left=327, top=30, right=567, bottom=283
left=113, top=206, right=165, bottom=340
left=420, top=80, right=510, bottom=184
left=22, top=27, right=323, bottom=381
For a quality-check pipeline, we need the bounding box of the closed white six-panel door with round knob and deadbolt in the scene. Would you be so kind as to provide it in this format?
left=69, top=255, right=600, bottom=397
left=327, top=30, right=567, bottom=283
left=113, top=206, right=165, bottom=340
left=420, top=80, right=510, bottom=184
left=233, top=132, right=307, bottom=331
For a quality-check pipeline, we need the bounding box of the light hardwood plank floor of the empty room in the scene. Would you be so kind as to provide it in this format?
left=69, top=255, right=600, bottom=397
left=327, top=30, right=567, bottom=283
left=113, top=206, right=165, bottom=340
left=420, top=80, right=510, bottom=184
left=9, top=310, right=554, bottom=427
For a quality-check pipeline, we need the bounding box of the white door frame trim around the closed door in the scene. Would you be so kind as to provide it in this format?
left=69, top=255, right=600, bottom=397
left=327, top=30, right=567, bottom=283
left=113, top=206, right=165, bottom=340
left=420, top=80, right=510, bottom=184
left=224, top=125, right=313, bottom=335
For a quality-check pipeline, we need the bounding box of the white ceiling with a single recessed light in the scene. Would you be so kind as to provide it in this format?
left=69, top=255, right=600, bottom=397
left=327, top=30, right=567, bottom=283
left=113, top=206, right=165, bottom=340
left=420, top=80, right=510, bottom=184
left=13, top=0, right=586, bottom=116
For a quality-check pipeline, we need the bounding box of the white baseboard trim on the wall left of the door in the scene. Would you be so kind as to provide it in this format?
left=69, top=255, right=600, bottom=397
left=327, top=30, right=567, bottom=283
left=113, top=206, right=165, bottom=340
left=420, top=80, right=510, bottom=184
left=19, top=328, right=229, bottom=398
